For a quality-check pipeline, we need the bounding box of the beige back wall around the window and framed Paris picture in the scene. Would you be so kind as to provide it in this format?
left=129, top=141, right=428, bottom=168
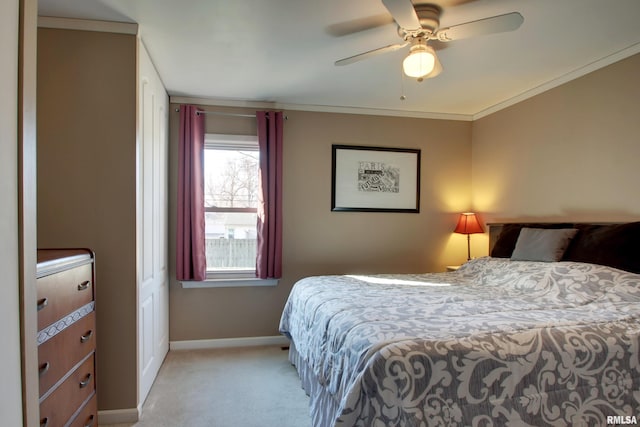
left=169, top=105, right=471, bottom=341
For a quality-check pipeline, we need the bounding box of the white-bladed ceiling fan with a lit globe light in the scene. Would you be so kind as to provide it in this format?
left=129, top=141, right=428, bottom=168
left=335, top=0, right=524, bottom=81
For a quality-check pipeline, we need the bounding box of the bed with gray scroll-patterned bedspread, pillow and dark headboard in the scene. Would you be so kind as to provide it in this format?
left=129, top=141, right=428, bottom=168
left=280, top=222, right=640, bottom=427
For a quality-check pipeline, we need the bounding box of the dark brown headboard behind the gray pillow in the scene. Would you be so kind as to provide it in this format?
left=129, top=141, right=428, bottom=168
left=487, top=222, right=640, bottom=273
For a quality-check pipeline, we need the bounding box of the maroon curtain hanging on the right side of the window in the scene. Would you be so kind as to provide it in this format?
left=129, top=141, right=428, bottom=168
left=256, top=111, right=283, bottom=279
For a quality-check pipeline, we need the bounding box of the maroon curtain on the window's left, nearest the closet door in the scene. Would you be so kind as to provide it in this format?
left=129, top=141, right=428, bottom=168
left=176, top=105, right=207, bottom=280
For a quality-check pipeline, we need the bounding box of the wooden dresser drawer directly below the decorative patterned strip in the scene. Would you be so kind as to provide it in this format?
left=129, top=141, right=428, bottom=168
left=38, top=311, right=96, bottom=396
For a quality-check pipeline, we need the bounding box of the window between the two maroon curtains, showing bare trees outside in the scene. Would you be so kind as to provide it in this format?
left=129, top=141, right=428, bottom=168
left=204, top=134, right=259, bottom=279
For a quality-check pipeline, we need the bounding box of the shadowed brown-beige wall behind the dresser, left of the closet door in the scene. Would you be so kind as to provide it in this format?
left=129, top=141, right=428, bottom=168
left=38, top=28, right=137, bottom=410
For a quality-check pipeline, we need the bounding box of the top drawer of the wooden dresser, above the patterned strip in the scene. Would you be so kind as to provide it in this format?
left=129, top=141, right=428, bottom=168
left=37, top=264, right=94, bottom=330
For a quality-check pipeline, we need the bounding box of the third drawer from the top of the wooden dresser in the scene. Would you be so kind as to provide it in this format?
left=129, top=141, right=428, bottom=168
left=40, top=354, right=95, bottom=427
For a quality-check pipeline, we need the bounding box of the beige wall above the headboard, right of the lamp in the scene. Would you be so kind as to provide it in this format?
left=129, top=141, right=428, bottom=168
left=472, top=55, right=640, bottom=247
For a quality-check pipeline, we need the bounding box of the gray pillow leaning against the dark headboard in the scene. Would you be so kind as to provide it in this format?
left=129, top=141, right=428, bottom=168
left=511, top=228, right=578, bottom=262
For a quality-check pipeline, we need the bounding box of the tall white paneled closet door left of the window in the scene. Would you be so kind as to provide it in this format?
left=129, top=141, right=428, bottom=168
left=137, top=41, right=169, bottom=408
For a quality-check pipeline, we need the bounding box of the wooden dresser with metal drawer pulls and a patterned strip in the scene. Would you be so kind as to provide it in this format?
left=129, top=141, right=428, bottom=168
left=36, top=249, right=98, bottom=427
